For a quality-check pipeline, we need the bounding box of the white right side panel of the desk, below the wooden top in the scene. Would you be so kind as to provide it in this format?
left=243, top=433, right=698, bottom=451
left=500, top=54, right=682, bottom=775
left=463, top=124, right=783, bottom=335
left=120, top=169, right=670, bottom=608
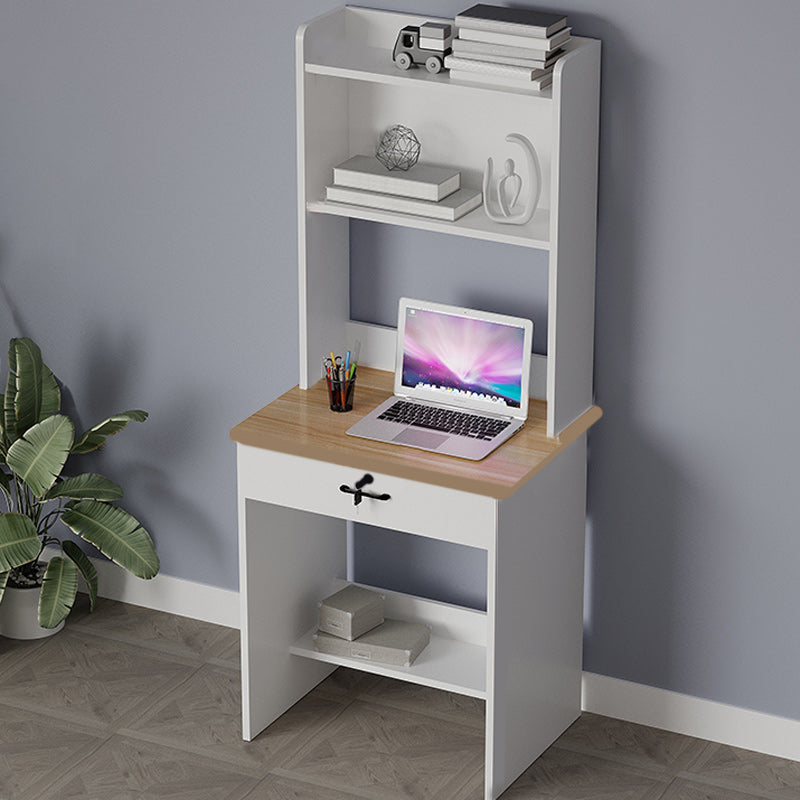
left=486, top=436, right=586, bottom=800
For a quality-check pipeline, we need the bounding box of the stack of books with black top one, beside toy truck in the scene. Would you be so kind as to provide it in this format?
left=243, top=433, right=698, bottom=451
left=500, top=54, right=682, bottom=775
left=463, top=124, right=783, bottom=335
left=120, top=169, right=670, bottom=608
left=444, top=4, right=570, bottom=89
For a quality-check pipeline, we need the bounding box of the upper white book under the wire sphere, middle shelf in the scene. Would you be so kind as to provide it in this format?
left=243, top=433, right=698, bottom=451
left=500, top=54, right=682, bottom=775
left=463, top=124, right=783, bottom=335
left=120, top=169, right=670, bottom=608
left=333, top=155, right=461, bottom=201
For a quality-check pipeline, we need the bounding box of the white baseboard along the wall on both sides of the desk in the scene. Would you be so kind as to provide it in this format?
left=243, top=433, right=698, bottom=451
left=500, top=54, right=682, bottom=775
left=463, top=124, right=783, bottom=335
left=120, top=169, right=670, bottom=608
left=69, top=559, right=800, bottom=761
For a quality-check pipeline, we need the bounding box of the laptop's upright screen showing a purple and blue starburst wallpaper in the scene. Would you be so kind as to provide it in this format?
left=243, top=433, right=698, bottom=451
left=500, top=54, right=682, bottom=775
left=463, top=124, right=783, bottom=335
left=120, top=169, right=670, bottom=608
left=398, top=299, right=532, bottom=416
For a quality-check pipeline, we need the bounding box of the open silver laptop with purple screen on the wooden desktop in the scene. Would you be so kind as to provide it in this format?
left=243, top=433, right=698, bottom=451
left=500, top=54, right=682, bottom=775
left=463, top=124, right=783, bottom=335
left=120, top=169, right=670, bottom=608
left=347, top=297, right=533, bottom=461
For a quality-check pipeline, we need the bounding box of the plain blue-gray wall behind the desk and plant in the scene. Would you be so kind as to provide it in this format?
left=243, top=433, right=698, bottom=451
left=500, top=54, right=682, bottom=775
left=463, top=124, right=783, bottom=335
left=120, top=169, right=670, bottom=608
left=0, top=0, right=800, bottom=719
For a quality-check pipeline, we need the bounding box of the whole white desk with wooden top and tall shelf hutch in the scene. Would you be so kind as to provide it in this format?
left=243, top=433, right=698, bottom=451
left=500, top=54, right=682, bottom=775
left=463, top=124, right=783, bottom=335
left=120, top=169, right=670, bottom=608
left=231, top=6, right=601, bottom=798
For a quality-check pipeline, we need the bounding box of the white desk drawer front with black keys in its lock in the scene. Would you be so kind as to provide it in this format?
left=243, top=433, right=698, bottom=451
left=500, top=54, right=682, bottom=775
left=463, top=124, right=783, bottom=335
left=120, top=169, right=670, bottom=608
left=237, top=445, right=497, bottom=549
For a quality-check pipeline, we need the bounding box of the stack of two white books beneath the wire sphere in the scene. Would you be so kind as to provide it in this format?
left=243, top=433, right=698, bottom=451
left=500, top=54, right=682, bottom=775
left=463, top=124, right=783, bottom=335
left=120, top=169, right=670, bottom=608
left=325, top=155, right=483, bottom=222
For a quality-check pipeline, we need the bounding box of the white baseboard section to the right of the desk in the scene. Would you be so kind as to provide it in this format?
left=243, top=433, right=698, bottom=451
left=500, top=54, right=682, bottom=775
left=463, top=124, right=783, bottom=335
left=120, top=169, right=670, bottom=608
left=582, top=672, right=800, bottom=761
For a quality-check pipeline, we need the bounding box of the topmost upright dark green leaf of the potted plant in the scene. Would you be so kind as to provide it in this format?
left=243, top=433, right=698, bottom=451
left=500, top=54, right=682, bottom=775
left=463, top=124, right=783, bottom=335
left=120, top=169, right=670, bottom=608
left=8, top=337, right=61, bottom=439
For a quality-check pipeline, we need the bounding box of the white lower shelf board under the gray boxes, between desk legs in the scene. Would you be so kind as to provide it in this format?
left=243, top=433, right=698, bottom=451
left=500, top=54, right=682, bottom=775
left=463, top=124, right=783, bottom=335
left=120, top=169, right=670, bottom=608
left=289, top=628, right=486, bottom=699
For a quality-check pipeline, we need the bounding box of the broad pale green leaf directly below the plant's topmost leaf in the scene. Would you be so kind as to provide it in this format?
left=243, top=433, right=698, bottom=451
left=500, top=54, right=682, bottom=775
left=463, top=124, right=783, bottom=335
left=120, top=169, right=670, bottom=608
left=6, top=414, right=75, bottom=497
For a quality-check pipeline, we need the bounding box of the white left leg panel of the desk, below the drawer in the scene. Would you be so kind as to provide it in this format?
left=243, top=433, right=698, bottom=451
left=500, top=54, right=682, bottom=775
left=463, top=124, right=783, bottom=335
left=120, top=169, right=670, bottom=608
left=239, top=498, right=347, bottom=741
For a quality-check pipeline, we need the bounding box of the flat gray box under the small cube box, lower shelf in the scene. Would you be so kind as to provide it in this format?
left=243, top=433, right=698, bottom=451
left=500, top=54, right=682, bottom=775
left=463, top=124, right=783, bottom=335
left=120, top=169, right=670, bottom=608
left=314, top=619, right=431, bottom=667
